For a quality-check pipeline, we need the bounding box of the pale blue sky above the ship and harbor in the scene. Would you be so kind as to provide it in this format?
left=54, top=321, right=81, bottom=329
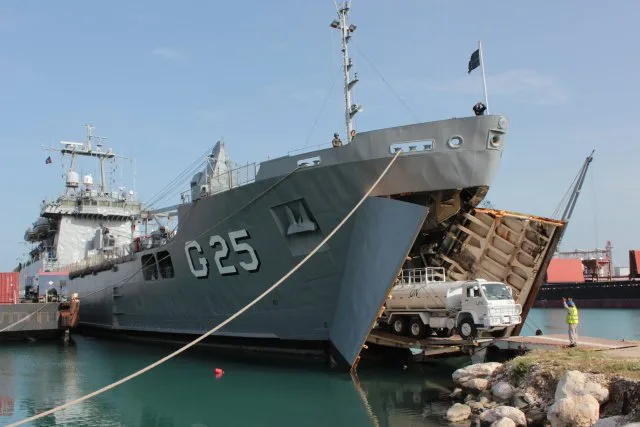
left=0, top=0, right=640, bottom=271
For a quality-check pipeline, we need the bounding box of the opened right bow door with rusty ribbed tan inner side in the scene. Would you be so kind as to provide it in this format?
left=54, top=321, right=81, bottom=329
left=430, top=208, right=566, bottom=336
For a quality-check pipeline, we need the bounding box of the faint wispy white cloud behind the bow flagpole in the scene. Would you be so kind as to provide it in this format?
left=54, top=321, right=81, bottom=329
left=413, top=69, right=569, bottom=105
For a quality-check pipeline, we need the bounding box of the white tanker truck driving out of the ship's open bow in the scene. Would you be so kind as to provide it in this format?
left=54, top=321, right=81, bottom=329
left=378, top=267, right=522, bottom=339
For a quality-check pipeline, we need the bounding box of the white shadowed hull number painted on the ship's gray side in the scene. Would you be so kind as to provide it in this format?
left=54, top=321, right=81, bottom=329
left=184, top=229, right=260, bottom=279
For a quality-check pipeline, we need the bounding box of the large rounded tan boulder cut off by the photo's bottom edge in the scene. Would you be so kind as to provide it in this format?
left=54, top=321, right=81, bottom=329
left=547, top=389, right=600, bottom=427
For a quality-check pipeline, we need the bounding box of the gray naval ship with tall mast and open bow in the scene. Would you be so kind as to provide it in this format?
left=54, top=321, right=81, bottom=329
left=12, top=3, right=507, bottom=370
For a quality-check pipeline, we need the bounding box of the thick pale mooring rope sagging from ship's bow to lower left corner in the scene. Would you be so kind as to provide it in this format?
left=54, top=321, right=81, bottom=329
left=7, top=150, right=401, bottom=427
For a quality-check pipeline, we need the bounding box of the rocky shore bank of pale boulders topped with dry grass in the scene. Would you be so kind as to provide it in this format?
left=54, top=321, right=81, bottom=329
left=446, top=350, right=640, bottom=427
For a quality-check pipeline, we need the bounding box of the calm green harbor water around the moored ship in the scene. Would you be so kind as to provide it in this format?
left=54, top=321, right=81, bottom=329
left=0, top=309, right=640, bottom=427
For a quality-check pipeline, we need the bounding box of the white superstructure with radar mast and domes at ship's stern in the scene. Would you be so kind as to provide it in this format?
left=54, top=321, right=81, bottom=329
left=20, top=125, right=140, bottom=293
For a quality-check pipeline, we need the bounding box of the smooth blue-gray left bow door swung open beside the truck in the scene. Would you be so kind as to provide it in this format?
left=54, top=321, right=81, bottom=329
left=329, top=197, right=428, bottom=370
